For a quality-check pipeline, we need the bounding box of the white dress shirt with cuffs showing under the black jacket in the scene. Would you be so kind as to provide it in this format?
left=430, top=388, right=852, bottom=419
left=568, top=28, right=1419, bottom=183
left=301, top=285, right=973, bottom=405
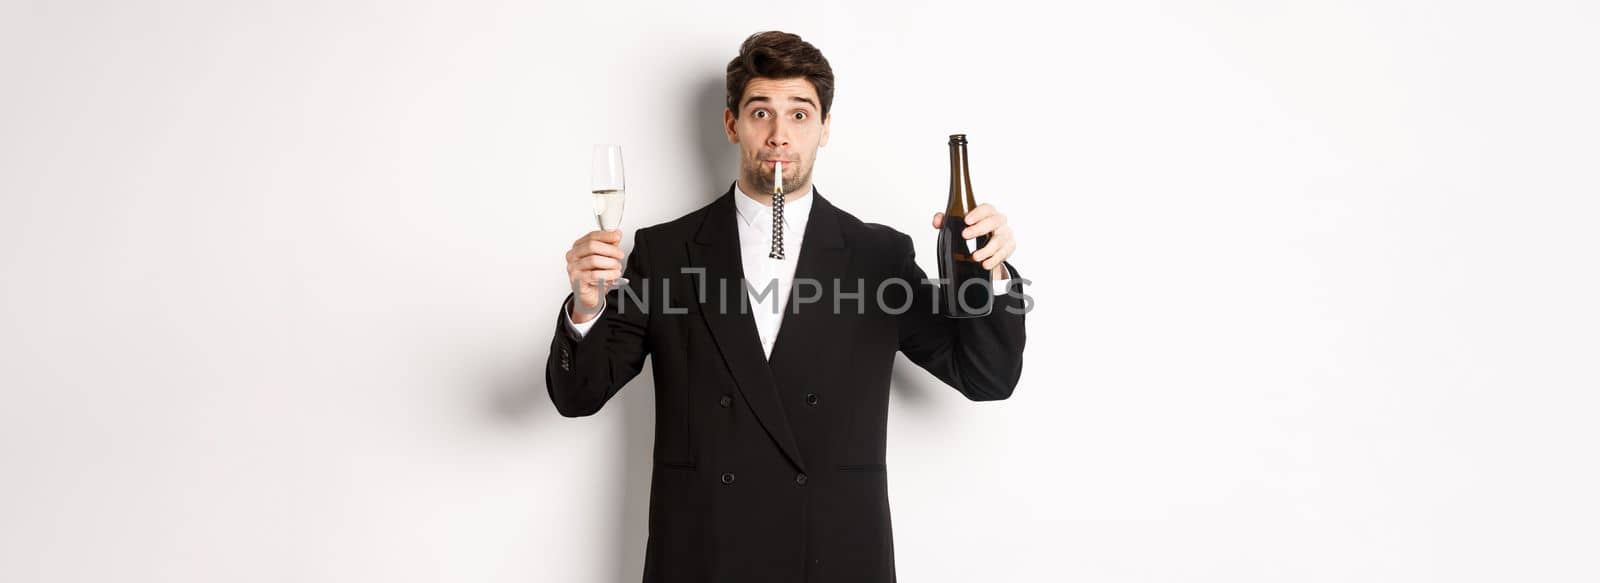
left=562, top=187, right=1011, bottom=359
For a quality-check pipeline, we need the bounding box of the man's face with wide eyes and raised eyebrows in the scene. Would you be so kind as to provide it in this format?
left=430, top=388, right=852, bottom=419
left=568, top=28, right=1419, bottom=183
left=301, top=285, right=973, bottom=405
left=723, top=77, right=834, bottom=194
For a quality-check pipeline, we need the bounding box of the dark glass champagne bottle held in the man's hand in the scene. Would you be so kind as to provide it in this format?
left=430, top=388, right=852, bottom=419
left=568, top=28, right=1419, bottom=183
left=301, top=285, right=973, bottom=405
left=938, top=133, right=994, bottom=317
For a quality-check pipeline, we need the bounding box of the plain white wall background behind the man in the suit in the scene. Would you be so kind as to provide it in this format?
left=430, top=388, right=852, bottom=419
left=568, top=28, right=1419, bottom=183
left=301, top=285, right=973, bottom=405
left=0, top=0, right=1600, bottom=583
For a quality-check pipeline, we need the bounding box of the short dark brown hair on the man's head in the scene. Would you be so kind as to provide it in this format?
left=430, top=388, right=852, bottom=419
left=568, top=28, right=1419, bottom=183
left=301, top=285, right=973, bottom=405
left=728, top=30, right=834, bottom=119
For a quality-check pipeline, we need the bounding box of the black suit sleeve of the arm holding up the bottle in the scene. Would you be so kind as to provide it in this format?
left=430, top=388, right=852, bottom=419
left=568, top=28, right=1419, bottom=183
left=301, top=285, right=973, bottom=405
left=896, top=234, right=1027, bottom=400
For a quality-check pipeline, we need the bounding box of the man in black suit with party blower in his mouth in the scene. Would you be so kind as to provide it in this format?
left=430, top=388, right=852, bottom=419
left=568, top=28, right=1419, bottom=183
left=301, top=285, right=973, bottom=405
left=546, top=32, right=1026, bottom=583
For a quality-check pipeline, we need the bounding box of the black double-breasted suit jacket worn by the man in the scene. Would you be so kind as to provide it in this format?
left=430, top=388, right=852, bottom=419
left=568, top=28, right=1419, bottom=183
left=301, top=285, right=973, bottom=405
left=546, top=186, right=1026, bottom=583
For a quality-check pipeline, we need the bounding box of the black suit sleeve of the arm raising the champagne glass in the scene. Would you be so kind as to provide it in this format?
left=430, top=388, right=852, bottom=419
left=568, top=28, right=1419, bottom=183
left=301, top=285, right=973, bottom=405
left=544, top=231, right=650, bottom=416
